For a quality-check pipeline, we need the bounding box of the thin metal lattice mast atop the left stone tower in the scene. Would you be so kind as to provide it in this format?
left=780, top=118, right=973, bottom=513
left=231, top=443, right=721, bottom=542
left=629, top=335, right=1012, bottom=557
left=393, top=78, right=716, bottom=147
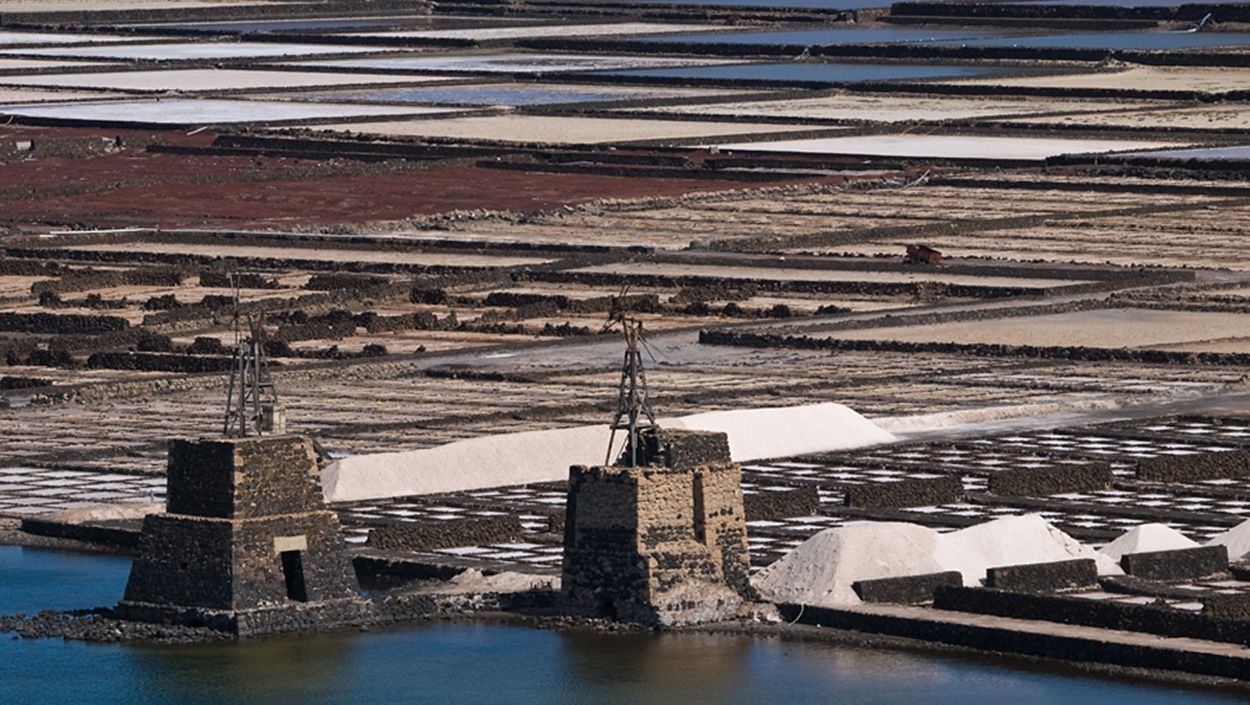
left=221, top=274, right=280, bottom=438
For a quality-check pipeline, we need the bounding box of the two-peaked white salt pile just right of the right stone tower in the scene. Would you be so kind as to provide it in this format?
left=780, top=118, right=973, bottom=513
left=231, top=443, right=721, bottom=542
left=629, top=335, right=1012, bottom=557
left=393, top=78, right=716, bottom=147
left=753, top=515, right=1121, bottom=608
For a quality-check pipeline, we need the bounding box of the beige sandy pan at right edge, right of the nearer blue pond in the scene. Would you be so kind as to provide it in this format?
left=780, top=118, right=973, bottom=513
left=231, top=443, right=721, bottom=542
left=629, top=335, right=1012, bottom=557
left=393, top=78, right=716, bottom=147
left=943, top=66, right=1250, bottom=93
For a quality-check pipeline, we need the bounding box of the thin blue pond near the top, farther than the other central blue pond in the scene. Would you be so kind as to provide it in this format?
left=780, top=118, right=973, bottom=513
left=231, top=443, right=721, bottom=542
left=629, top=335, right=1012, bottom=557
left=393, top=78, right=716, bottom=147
left=638, top=28, right=1003, bottom=46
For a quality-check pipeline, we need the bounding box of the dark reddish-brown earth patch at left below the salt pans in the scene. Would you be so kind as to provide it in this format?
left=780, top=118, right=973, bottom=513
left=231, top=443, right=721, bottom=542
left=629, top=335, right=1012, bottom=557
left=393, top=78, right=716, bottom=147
left=3, top=160, right=840, bottom=229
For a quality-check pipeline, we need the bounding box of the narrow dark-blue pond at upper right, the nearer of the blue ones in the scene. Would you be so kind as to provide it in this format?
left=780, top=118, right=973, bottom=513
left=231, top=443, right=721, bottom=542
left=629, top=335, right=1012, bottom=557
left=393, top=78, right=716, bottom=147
left=600, top=61, right=1001, bottom=84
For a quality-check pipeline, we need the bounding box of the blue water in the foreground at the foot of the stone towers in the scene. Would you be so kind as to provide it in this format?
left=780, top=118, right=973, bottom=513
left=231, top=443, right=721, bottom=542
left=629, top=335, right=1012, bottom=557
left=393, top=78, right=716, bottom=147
left=0, top=546, right=1243, bottom=705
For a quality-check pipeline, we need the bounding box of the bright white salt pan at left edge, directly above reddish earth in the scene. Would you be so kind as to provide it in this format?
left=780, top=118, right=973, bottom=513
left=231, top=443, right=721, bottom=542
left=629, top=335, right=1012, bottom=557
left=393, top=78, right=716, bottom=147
left=0, top=99, right=455, bottom=125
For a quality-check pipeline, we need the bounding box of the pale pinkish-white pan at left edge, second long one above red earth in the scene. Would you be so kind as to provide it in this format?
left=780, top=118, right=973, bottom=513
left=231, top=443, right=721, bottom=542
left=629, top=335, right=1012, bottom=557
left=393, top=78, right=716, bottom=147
left=0, top=68, right=460, bottom=91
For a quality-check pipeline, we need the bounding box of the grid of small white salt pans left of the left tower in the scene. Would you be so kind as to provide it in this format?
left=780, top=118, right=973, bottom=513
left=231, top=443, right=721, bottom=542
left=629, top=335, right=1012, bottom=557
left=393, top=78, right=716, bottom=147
left=0, top=468, right=165, bottom=516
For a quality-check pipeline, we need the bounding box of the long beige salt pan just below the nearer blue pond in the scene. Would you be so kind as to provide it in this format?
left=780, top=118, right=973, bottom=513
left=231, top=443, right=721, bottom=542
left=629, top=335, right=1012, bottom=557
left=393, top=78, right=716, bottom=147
left=634, top=94, right=1165, bottom=123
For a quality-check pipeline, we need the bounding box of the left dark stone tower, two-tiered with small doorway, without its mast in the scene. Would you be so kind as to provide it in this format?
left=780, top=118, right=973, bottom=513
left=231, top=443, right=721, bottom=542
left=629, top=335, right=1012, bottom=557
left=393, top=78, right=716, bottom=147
left=118, top=435, right=368, bottom=636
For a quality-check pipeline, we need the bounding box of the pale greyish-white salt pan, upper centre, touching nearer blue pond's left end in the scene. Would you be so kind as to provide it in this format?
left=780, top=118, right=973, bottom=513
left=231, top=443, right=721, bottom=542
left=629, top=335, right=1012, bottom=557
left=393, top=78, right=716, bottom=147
left=296, top=54, right=733, bottom=74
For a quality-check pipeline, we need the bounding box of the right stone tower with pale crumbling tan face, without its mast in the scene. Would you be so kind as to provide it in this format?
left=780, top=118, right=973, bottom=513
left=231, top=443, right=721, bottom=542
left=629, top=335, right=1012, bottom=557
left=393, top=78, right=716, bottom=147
left=561, top=429, right=751, bottom=625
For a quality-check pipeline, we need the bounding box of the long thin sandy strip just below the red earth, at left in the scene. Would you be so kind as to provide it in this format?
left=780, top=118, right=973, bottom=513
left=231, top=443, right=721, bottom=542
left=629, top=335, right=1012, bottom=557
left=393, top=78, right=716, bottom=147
left=66, top=243, right=551, bottom=266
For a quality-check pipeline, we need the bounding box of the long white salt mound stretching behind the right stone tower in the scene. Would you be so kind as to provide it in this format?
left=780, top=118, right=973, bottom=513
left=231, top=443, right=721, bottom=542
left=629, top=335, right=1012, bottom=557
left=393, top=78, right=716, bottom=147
left=321, top=404, right=895, bottom=501
